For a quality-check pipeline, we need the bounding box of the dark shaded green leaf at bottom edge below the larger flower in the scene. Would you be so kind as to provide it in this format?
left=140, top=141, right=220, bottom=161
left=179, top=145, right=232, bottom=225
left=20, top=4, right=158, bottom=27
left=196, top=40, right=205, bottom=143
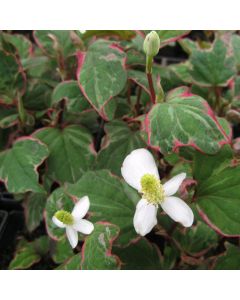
left=113, top=238, right=161, bottom=270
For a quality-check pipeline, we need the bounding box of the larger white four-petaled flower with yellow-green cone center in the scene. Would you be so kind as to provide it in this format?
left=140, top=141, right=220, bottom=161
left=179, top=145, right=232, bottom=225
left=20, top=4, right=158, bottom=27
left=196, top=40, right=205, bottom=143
left=121, top=149, right=194, bottom=236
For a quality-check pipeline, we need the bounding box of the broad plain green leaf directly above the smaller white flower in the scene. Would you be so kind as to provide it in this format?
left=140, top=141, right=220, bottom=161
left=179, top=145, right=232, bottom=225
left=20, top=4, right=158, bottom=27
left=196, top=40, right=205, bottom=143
left=33, top=125, right=95, bottom=182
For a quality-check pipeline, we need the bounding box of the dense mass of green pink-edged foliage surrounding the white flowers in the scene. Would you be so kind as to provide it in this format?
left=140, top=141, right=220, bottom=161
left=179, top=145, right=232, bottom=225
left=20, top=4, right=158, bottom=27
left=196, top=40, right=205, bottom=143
left=0, top=31, right=240, bottom=270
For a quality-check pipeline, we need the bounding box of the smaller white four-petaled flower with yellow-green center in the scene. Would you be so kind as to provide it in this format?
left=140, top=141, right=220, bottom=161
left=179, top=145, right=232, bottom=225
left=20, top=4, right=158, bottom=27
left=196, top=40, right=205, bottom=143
left=52, top=196, right=94, bottom=248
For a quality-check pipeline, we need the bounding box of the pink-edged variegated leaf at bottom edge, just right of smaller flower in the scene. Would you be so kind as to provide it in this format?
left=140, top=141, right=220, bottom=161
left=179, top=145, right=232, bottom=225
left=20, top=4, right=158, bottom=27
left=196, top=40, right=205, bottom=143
left=81, top=223, right=120, bottom=270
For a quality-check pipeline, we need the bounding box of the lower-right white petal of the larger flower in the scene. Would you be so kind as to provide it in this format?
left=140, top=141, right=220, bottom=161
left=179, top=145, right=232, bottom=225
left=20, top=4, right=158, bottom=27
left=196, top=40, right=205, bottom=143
left=161, top=197, right=194, bottom=227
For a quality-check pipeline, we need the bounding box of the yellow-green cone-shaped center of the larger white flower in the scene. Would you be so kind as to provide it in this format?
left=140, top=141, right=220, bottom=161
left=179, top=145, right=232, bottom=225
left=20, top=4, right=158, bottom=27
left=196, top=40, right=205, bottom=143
left=141, top=174, right=165, bottom=205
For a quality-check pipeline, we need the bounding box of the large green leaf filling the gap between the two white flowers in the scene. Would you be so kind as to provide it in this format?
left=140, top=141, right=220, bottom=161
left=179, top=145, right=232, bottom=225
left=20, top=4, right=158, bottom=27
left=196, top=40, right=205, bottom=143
left=67, top=170, right=140, bottom=245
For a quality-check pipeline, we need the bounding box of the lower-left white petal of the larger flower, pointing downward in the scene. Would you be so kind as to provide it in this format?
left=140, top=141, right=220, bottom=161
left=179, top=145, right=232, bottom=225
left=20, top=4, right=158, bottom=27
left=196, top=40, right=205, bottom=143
left=133, top=199, right=157, bottom=236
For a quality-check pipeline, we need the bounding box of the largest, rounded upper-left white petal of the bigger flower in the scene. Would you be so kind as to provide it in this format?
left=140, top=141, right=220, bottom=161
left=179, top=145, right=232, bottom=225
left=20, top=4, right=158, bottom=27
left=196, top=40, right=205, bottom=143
left=121, top=148, right=159, bottom=191
